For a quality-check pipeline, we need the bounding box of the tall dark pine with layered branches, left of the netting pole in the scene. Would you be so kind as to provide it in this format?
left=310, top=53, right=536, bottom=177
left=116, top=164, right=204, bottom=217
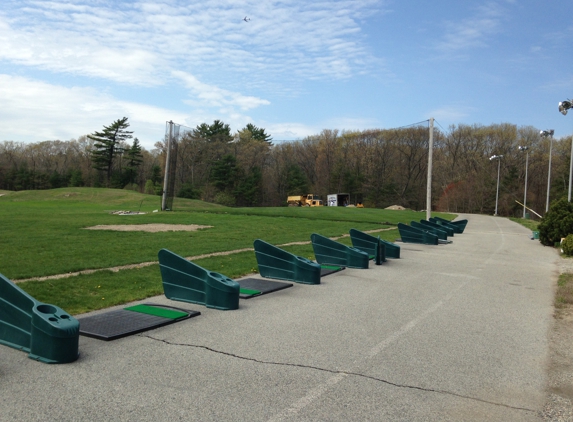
left=88, top=117, right=133, bottom=185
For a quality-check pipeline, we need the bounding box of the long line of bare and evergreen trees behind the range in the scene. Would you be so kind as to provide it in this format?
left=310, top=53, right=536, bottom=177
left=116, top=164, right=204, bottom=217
left=0, top=118, right=571, bottom=216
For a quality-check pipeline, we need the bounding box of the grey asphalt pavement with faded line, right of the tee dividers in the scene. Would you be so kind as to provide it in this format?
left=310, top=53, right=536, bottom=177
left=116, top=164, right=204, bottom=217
left=0, top=215, right=558, bottom=422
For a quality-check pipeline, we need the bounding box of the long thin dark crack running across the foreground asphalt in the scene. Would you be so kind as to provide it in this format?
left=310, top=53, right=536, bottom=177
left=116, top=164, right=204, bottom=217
left=138, top=334, right=537, bottom=413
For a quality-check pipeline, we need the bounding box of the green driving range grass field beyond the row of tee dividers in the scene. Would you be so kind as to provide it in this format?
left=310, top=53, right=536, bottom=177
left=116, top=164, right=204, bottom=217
left=0, top=188, right=453, bottom=314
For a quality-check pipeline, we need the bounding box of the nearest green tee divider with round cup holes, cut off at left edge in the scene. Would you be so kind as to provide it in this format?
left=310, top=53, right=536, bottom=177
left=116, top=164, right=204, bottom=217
left=0, top=274, right=80, bottom=363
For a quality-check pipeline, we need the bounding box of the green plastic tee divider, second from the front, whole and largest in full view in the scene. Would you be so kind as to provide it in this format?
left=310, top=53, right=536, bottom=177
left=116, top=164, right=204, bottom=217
left=158, top=249, right=240, bottom=310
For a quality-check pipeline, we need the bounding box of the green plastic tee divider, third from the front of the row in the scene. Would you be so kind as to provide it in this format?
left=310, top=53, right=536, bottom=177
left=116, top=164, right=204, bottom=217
left=254, top=239, right=320, bottom=284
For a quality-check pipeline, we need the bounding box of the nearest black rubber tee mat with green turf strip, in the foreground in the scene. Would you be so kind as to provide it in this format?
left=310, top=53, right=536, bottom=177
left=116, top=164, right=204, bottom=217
left=78, top=303, right=201, bottom=341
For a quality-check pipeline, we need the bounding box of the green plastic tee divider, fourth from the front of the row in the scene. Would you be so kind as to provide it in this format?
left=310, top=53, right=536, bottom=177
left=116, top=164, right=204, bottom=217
left=310, top=233, right=370, bottom=269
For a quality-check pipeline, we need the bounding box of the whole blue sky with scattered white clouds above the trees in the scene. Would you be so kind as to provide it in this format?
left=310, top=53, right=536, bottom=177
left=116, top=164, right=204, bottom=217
left=0, top=0, right=573, bottom=149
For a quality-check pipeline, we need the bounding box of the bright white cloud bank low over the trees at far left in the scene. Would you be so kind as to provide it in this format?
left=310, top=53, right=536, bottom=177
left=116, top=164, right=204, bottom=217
left=0, top=74, right=187, bottom=149
